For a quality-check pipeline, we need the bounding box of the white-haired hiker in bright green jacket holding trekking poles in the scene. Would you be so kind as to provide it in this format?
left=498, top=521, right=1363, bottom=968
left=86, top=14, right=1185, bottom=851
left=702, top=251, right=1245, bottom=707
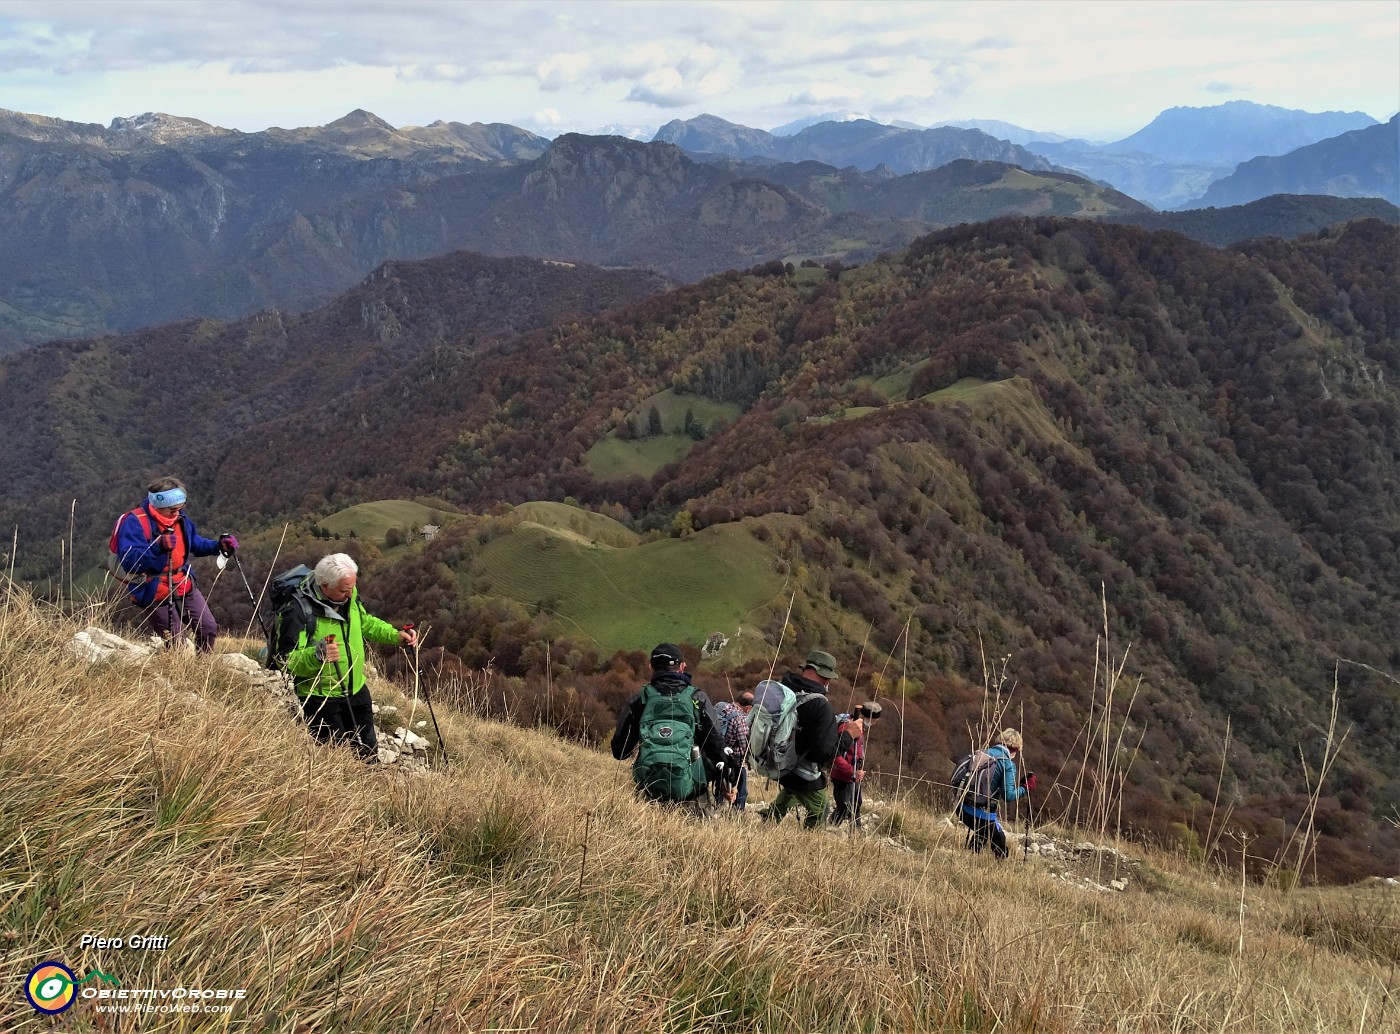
left=286, top=553, right=417, bottom=765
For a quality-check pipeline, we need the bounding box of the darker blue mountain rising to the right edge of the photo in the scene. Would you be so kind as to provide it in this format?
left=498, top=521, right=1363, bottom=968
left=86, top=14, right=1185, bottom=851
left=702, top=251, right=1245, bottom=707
left=1183, top=116, right=1400, bottom=208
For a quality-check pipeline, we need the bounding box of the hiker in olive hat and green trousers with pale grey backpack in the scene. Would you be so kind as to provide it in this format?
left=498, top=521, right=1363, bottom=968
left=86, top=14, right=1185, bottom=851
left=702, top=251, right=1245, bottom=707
left=749, top=649, right=839, bottom=830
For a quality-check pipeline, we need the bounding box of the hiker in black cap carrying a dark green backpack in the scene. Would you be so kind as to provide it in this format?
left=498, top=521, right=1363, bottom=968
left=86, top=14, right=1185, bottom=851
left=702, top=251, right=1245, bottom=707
left=612, top=642, right=738, bottom=807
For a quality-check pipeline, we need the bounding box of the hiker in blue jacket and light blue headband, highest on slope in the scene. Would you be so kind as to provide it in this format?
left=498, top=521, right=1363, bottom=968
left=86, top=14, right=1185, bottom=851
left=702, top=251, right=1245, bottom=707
left=108, top=477, right=238, bottom=653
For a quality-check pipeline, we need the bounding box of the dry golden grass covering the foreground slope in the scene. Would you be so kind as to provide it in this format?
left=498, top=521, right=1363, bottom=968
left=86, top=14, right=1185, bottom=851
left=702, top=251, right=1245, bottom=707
left=0, top=597, right=1400, bottom=1034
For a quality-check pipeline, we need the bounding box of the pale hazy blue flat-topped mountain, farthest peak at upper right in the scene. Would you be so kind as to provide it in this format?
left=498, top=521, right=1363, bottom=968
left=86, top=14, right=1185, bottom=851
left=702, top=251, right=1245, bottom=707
left=1105, top=101, right=1376, bottom=165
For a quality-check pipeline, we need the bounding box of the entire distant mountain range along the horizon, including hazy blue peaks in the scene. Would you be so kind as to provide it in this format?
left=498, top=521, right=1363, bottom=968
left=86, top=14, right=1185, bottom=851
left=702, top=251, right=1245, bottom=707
left=0, top=105, right=1394, bottom=353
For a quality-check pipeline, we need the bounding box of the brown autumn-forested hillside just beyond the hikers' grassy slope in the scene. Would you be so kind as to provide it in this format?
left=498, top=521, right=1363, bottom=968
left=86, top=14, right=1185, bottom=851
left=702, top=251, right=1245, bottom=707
left=3, top=218, right=1400, bottom=879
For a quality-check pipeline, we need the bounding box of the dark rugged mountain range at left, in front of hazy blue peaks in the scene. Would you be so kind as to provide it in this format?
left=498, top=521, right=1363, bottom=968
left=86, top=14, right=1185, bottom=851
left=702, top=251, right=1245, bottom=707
left=0, top=109, right=1144, bottom=345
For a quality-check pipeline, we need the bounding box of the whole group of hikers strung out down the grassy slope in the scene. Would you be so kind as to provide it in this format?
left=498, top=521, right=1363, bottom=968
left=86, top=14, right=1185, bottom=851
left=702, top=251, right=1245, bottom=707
left=109, top=477, right=1036, bottom=858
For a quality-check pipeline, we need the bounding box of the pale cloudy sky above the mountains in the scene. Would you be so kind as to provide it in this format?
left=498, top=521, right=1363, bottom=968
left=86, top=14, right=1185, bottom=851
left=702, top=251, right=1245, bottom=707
left=0, top=0, right=1400, bottom=140
